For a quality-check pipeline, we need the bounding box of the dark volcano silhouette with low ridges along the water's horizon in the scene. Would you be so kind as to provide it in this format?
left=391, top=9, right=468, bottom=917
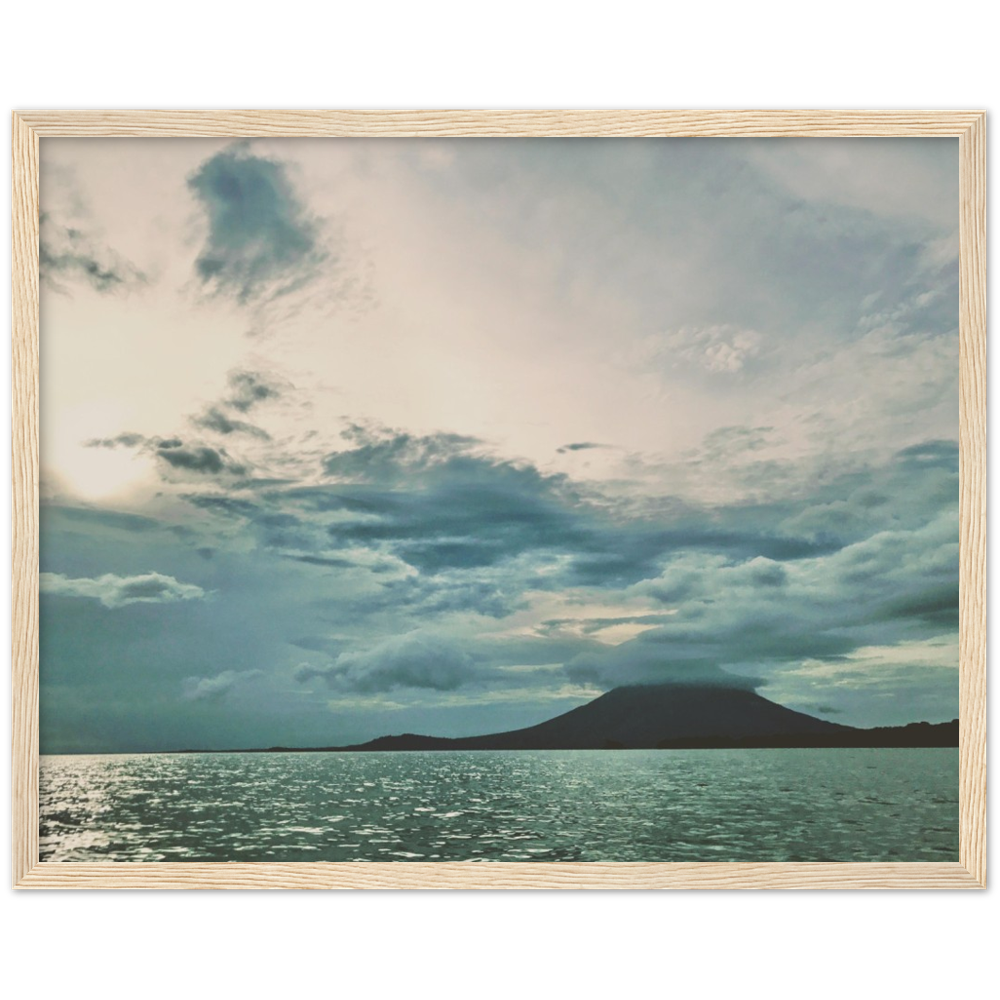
left=324, top=684, right=958, bottom=751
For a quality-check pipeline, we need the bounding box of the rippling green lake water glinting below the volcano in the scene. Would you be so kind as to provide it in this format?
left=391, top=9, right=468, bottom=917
left=39, top=749, right=958, bottom=861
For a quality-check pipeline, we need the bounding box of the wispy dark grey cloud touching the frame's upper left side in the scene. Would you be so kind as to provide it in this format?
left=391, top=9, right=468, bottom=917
left=38, top=212, right=146, bottom=293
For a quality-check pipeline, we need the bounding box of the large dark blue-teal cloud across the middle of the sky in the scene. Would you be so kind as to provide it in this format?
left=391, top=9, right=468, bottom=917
left=320, top=430, right=828, bottom=586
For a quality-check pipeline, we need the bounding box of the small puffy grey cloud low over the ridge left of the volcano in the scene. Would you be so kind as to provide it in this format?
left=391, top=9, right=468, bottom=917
left=295, top=631, right=478, bottom=694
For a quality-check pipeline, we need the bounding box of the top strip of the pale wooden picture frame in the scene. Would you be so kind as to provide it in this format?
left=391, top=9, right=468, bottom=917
left=9, top=108, right=985, bottom=136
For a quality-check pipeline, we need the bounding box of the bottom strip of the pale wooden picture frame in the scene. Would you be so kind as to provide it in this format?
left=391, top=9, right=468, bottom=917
left=11, top=861, right=982, bottom=890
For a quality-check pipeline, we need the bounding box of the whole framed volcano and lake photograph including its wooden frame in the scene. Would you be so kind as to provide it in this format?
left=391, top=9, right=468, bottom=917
left=11, top=109, right=986, bottom=889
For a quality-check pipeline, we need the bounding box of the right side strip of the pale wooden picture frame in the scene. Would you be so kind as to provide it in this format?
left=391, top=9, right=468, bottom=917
left=959, top=115, right=986, bottom=885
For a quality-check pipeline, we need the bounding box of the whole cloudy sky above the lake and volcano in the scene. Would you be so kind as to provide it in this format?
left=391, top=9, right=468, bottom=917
left=40, top=138, right=959, bottom=753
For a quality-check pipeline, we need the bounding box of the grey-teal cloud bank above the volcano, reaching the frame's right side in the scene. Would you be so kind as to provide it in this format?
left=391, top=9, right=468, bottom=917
left=567, top=496, right=958, bottom=686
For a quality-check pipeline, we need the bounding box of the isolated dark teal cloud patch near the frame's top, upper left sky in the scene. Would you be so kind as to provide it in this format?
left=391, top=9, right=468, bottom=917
left=188, top=144, right=324, bottom=304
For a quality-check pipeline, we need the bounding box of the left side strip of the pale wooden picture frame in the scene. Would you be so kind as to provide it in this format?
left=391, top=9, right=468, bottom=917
left=10, top=113, right=38, bottom=883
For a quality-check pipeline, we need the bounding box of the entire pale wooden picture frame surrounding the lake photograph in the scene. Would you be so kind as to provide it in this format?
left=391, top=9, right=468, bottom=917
left=11, top=108, right=986, bottom=890
